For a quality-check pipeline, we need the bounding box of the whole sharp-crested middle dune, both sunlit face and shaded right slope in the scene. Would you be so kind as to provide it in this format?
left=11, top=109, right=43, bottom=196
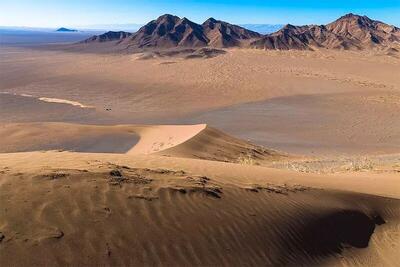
left=0, top=123, right=287, bottom=163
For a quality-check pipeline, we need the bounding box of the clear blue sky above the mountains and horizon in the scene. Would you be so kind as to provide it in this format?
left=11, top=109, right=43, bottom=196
left=0, top=0, right=400, bottom=27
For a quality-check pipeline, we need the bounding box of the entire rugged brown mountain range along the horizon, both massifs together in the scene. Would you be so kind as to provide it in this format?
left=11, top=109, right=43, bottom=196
left=80, top=13, right=400, bottom=51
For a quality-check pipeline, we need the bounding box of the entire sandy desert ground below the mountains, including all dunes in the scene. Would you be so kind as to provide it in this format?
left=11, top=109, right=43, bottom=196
left=0, top=47, right=400, bottom=266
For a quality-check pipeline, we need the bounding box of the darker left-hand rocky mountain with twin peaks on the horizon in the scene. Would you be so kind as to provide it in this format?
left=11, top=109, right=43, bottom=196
left=84, top=14, right=262, bottom=50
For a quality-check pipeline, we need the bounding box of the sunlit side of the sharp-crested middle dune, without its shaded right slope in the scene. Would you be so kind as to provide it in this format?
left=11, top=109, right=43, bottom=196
left=0, top=123, right=206, bottom=155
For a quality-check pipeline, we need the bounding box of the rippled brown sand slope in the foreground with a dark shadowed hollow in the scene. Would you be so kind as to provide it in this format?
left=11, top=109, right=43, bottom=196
left=0, top=152, right=400, bottom=266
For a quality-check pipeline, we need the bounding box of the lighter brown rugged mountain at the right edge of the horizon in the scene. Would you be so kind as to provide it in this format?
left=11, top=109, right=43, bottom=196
left=250, top=14, right=400, bottom=50
